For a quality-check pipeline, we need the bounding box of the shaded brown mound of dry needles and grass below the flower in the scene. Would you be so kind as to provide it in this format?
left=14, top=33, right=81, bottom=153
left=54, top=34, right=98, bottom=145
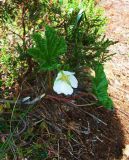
left=0, top=93, right=125, bottom=160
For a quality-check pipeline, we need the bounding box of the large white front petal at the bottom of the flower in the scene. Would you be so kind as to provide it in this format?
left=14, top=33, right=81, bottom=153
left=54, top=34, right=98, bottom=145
left=53, top=80, right=73, bottom=95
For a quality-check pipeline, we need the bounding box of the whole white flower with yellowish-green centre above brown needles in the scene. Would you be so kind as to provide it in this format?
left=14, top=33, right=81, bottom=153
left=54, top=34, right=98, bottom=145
left=53, top=71, right=78, bottom=95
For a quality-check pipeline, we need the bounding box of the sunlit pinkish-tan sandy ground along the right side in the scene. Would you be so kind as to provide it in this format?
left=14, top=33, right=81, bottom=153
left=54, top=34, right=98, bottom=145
left=100, top=0, right=129, bottom=157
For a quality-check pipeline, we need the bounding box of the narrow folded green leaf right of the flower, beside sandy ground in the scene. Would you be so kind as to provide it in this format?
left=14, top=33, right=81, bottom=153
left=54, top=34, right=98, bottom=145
left=92, top=63, right=113, bottom=109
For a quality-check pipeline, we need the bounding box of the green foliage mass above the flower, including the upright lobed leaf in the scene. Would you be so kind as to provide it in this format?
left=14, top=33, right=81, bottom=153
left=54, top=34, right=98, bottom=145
left=0, top=0, right=115, bottom=106
